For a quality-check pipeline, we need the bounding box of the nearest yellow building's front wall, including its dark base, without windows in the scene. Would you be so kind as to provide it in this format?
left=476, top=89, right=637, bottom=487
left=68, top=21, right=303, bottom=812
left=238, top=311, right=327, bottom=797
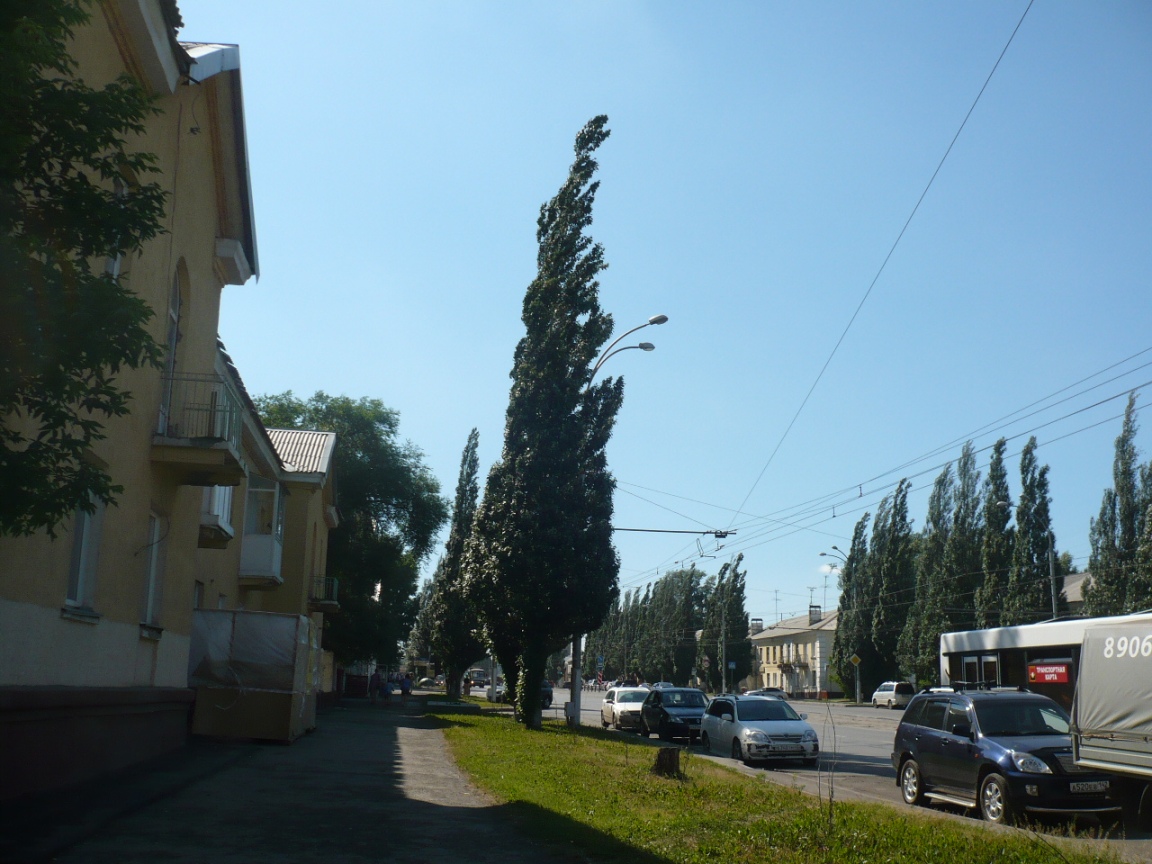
left=0, top=0, right=255, bottom=798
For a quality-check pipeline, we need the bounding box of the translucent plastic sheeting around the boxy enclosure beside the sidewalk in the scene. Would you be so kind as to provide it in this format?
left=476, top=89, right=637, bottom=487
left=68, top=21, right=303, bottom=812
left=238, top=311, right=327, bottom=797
left=188, top=609, right=318, bottom=694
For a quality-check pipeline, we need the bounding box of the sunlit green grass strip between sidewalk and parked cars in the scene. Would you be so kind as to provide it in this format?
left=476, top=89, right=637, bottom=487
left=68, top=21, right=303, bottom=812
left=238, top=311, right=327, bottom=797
left=430, top=706, right=1115, bottom=864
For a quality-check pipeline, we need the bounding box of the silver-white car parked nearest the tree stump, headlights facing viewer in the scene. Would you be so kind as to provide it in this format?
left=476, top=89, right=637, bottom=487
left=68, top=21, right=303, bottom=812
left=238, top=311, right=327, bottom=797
left=700, top=695, right=820, bottom=765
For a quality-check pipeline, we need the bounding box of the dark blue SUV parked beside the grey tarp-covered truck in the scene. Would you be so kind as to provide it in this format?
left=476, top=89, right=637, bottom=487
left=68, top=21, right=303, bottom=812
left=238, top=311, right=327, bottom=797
left=892, top=689, right=1119, bottom=824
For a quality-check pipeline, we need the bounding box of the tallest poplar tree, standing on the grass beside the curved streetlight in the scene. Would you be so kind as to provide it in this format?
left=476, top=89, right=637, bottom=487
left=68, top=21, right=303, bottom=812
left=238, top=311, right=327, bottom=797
left=465, top=115, right=623, bottom=728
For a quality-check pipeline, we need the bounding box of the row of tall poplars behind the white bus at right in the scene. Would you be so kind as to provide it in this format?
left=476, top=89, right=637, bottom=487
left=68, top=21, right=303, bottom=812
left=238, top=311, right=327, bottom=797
left=831, top=393, right=1152, bottom=692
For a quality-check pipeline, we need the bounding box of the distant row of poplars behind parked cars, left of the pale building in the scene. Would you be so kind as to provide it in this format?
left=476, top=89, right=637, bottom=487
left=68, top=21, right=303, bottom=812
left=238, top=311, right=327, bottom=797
left=585, top=555, right=753, bottom=691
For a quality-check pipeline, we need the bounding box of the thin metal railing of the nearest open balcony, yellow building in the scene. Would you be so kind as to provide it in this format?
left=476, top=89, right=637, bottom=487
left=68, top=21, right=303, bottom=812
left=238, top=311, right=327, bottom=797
left=157, top=372, right=241, bottom=448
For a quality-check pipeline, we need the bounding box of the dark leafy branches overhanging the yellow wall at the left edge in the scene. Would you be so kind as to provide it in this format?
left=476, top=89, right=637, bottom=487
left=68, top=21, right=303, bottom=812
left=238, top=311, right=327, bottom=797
left=0, top=0, right=166, bottom=536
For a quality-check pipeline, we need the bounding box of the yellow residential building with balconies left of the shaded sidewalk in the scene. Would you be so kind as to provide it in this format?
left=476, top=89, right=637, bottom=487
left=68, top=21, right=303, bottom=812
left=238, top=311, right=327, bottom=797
left=0, top=0, right=335, bottom=799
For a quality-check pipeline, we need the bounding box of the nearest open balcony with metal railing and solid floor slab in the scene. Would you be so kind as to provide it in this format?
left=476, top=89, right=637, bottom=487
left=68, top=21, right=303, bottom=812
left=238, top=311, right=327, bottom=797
left=152, top=373, right=244, bottom=486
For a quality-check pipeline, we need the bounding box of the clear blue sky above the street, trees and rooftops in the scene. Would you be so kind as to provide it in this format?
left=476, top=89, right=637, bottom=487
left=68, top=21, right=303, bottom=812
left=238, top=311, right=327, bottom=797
left=181, top=0, right=1152, bottom=620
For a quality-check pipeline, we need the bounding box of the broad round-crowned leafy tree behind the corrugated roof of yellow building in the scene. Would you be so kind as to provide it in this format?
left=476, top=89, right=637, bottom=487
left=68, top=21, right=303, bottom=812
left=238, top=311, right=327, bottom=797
left=255, top=391, right=448, bottom=666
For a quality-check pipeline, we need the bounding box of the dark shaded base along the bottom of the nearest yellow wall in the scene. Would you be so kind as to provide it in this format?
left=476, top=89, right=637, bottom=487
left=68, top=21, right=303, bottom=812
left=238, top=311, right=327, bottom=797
left=0, top=687, right=196, bottom=801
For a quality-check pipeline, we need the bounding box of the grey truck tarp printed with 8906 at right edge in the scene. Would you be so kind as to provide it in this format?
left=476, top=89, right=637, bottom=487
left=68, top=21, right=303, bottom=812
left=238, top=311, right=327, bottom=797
left=1073, top=615, right=1152, bottom=776
